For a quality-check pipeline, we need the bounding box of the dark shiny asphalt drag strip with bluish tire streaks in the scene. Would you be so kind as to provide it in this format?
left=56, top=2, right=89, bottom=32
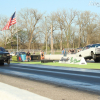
left=0, top=63, right=100, bottom=94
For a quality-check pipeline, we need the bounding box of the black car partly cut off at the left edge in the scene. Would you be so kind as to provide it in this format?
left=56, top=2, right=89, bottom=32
left=0, top=47, right=10, bottom=65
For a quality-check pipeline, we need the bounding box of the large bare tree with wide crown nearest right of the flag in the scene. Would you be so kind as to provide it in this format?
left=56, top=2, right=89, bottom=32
left=19, top=9, right=42, bottom=49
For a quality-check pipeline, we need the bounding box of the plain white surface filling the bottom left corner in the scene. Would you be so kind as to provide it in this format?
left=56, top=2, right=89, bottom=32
left=0, top=82, right=51, bottom=100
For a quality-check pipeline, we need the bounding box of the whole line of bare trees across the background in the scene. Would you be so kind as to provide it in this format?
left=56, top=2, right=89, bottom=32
left=0, top=8, right=100, bottom=52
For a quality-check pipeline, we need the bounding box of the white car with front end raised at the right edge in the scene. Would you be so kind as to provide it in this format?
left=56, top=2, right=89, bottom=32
left=76, top=44, right=100, bottom=62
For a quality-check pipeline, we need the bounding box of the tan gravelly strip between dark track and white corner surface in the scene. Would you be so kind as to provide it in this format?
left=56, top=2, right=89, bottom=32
left=0, top=74, right=100, bottom=100
